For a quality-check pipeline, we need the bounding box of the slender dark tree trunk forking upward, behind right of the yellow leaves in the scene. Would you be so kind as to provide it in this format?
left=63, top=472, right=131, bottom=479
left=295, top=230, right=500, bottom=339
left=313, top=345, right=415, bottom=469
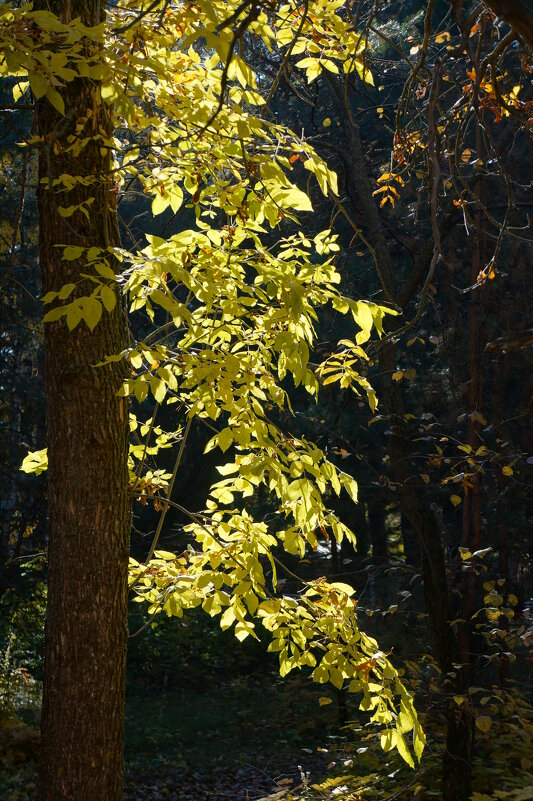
left=327, top=76, right=473, bottom=801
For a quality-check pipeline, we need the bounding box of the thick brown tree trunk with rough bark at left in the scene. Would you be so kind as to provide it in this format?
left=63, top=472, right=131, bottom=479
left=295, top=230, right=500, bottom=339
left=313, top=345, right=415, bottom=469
left=37, top=0, right=130, bottom=801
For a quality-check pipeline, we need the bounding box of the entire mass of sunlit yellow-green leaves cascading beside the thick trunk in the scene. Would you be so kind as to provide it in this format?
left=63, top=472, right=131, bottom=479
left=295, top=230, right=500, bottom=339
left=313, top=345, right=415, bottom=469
left=5, top=0, right=423, bottom=765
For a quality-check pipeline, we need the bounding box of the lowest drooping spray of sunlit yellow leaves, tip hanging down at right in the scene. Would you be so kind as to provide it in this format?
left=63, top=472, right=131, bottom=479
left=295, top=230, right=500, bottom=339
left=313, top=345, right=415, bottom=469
left=131, top=540, right=425, bottom=765
